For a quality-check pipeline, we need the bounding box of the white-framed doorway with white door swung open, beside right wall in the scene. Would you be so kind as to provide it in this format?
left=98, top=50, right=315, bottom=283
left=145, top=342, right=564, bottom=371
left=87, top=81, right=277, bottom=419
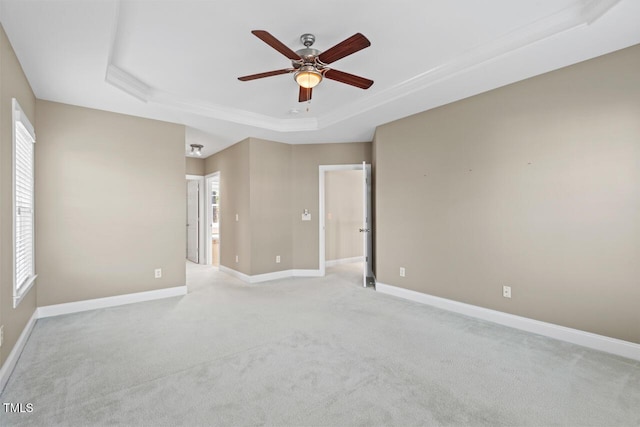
left=319, top=162, right=375, bottom=287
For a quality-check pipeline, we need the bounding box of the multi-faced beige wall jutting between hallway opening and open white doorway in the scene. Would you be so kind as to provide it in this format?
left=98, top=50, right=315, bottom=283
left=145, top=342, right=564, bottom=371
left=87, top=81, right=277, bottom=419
left=205, top=138, right=371, bottom=275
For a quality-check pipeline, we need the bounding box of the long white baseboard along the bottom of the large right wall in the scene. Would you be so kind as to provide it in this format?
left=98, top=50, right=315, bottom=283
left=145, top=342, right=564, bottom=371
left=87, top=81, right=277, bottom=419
left=376, top=282, right=640, bottom=360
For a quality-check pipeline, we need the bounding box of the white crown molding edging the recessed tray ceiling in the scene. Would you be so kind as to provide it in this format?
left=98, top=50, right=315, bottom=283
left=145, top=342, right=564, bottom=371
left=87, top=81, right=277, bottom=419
left=105, top=0, right=621, bottom=132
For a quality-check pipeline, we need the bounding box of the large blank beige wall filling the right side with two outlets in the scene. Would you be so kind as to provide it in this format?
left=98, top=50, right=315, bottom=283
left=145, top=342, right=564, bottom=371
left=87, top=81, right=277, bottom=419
left=375, top=46, right=640, bottom=343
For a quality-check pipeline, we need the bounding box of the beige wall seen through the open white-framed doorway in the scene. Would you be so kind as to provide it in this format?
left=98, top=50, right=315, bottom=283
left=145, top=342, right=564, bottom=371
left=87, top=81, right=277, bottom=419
left=324, top=171, right=364, bottom=261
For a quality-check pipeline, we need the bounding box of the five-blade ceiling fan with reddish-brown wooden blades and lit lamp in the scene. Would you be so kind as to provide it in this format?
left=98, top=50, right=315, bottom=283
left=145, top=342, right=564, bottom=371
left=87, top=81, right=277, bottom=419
left=238, top=30, right=373, bottom=102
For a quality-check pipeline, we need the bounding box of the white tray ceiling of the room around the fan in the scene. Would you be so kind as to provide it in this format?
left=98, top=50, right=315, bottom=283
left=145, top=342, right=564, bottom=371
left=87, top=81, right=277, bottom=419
left=0, top=0, right=640, bottom=156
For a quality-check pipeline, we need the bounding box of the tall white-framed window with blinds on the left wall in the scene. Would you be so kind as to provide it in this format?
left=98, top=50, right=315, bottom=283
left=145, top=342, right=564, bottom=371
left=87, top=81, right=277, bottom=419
left=13, top=98, right=36, bottom=308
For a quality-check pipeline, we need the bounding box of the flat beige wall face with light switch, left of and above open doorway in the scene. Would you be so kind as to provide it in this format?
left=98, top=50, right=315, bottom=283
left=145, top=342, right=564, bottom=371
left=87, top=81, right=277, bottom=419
left=291, top=142, right=371, bottom=270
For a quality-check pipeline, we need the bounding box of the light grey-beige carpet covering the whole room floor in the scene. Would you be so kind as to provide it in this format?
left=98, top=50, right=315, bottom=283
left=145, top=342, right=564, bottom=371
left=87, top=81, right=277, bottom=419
left=0, top=264, right=640, bottom=426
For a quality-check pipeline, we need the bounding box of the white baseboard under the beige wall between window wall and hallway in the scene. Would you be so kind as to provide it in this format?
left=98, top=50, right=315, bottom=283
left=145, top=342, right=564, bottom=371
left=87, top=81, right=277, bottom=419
left=37, top=286, right=187, bottom=319
